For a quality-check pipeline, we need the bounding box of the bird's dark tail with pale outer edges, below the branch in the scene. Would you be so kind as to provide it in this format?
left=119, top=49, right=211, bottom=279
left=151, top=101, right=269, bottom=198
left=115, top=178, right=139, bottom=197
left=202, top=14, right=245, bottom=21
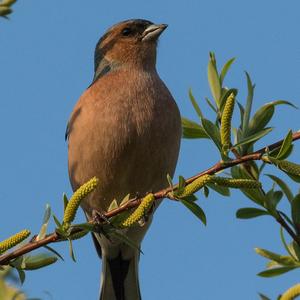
left=100, top=252, right=141, bottom=300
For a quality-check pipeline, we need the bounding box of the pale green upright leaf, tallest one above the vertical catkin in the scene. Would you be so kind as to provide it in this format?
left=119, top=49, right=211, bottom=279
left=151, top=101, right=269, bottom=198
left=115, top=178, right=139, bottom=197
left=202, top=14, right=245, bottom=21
left=207, top=52, right=221, bottom=107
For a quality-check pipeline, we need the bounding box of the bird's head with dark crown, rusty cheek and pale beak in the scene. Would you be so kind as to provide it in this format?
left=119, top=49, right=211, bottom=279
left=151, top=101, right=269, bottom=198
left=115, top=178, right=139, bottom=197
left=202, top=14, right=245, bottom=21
left=95, top=19, right=167, bottom=77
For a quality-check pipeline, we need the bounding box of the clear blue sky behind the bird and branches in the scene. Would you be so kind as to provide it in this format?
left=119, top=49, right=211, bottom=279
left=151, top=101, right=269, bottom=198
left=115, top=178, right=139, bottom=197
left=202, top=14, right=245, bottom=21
left=0, top=0, right=300, bottom=300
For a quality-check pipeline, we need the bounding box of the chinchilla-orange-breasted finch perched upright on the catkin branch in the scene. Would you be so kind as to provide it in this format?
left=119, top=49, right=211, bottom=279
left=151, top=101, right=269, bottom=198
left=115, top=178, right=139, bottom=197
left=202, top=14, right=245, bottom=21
left=66, top=19, right=181, bottom=300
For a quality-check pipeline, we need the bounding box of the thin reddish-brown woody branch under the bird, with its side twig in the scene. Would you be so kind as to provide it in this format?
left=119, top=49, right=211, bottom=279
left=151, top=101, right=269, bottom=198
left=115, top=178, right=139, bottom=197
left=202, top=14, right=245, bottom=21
left=0, top=132, right=300, bottom=265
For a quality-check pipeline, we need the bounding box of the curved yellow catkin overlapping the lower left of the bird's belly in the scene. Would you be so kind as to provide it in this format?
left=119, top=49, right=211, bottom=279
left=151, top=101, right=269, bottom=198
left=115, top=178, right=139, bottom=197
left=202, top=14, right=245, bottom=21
left=63, top=177, right=99, bottom=224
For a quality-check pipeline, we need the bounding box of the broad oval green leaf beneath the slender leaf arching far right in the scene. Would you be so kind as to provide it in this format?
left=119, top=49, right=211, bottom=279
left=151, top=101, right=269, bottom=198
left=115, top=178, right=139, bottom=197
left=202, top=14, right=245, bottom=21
left=248, top=104, right=275, bottom=135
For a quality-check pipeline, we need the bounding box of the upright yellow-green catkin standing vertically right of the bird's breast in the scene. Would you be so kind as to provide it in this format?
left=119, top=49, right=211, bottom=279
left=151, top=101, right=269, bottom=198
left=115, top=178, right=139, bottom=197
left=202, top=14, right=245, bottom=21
left=220, top=93, right=235, bottom=150
